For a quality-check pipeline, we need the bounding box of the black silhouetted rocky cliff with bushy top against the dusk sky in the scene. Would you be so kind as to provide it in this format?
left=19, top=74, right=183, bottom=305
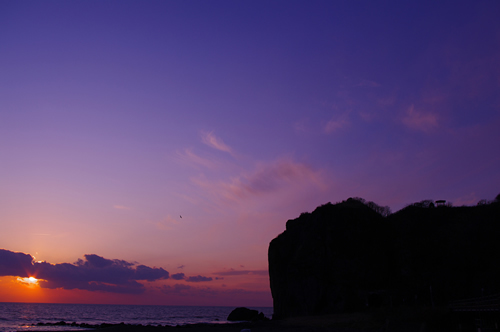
left=268, top=195, right=500, bottom=319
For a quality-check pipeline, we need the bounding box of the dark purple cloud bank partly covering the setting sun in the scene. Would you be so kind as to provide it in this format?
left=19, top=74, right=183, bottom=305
left=0, top=249, right=169, bottom=294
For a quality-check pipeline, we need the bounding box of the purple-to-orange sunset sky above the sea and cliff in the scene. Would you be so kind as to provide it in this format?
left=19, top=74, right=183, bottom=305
left=0, top=0, right=500, bottom=306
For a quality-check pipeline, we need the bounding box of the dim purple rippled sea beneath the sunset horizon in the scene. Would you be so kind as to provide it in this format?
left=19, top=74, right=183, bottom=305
left=0, top=303, right=273, bottom=332
